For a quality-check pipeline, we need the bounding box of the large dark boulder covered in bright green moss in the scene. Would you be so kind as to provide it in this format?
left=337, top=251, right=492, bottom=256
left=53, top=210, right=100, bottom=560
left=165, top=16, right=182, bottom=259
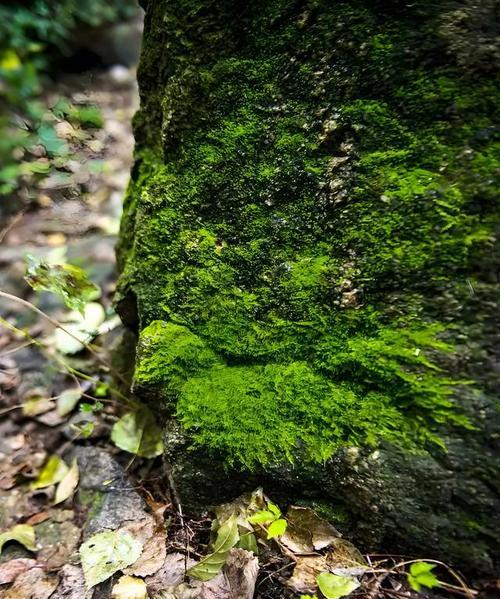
left=117, top=0, right=500, bottom=574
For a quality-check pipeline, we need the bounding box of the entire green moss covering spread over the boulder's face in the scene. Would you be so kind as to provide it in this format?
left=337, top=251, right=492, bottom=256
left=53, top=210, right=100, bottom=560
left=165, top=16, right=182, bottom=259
left=121, top=0, right=500, bottom=467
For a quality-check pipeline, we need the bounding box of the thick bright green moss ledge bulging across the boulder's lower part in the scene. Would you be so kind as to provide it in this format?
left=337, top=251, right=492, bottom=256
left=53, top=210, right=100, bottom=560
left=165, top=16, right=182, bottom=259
left=134, top=316, right=467, bottom=469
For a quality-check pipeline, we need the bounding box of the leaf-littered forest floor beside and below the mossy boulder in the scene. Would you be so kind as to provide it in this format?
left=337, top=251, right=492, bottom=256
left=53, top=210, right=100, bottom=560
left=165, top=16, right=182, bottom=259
left=0, top=56, right=486, bottom=599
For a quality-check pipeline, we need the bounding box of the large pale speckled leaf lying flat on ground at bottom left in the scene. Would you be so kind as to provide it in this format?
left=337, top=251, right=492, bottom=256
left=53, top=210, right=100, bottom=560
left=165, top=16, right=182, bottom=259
left=80, top=530, right=143, bottom=589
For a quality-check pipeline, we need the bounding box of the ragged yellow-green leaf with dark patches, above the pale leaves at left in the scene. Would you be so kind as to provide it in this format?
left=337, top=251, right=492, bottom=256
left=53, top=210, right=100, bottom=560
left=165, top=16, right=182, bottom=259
left=25, top=255, right=100, bottom=314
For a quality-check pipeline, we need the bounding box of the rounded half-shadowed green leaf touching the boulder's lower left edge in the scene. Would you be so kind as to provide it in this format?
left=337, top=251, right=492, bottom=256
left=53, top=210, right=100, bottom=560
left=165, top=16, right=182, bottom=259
left=111, top=406, right=163, bottom=458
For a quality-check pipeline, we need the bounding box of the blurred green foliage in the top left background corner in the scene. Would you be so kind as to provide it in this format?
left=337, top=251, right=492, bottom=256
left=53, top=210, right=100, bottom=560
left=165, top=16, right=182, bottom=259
left=0, top=0, right=137, bottom=195
